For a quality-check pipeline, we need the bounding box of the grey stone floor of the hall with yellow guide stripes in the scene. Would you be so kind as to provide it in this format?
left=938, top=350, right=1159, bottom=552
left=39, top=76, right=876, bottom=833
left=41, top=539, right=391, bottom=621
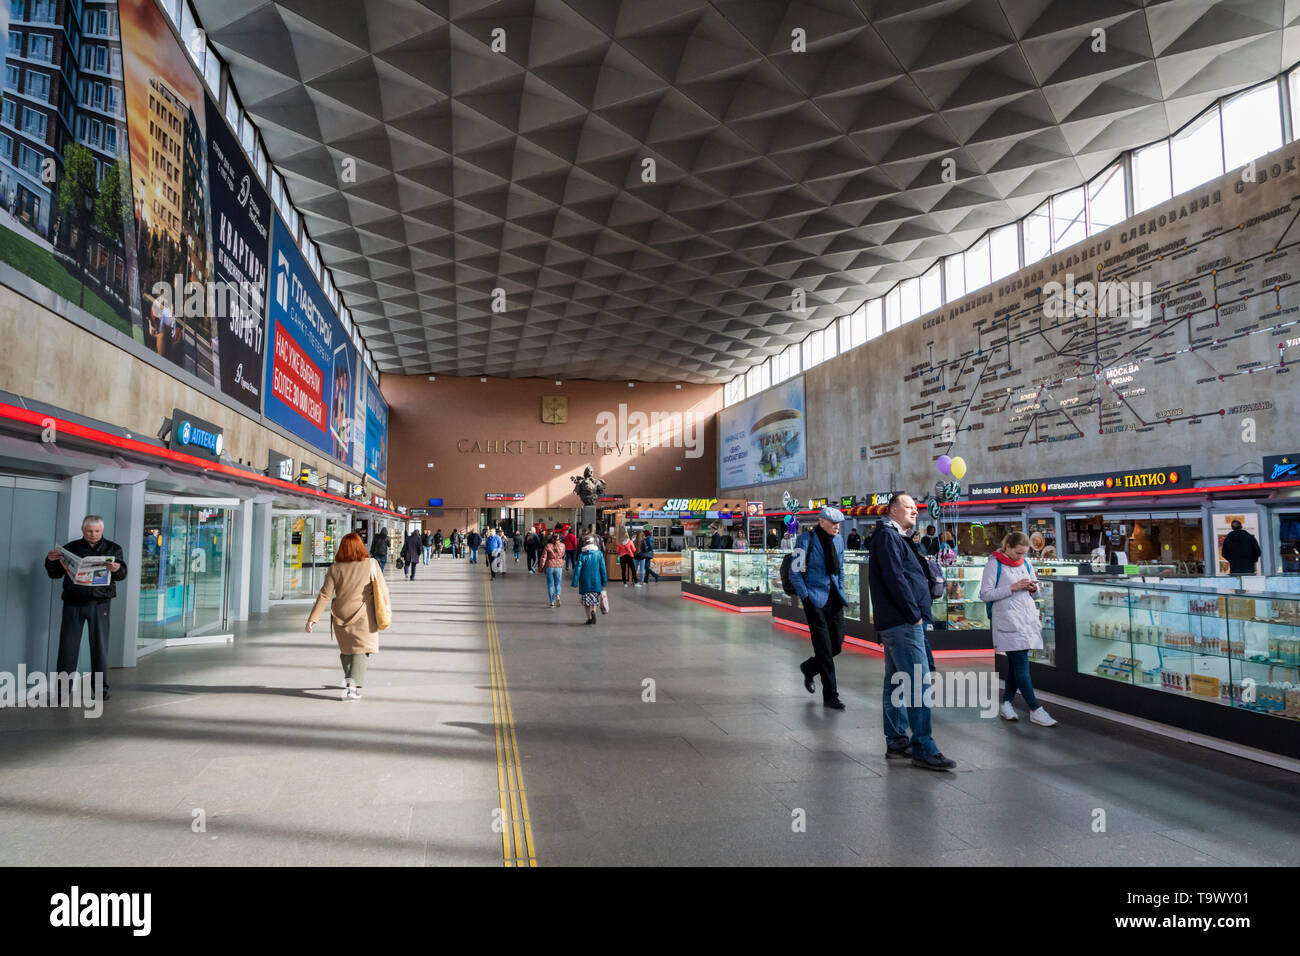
left=0, top=558, right=1300, bottom=866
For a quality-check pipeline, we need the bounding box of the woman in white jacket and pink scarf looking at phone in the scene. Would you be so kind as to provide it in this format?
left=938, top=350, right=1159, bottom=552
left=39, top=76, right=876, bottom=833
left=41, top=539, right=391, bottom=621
left=979, top=531, right=1056, bottom=727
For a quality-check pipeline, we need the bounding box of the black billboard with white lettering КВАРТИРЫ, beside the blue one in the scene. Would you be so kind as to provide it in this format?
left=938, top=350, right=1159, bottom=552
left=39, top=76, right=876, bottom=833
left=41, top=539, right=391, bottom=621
left=205, top=98, right=270, bottom=414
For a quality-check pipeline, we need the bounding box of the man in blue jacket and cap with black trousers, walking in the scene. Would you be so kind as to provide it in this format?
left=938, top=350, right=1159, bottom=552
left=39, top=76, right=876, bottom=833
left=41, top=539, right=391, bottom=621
left=790, top=507, right=846, bottom=710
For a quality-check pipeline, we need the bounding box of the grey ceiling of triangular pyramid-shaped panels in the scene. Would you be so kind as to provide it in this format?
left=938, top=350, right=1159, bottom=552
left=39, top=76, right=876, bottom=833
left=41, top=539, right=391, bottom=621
left=192, top=0, right=1300, bottom=382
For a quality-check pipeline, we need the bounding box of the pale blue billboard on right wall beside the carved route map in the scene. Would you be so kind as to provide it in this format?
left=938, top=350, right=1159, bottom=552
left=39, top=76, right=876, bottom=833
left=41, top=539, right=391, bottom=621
left=718, top=376, right=807, bottom=488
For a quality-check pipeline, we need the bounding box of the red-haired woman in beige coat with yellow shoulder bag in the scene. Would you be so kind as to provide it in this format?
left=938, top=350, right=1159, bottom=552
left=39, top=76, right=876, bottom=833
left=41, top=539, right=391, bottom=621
left=307, top=532, right=389, bottom=700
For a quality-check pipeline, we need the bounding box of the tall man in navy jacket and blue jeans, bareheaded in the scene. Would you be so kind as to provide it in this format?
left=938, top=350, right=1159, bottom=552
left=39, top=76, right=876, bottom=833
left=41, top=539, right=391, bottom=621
left=867, top=494, right=957, bottom=770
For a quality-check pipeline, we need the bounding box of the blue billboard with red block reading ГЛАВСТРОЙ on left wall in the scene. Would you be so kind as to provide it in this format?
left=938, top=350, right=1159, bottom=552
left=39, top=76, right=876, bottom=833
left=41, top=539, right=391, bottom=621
left=264, top=212, right=356, bottom=466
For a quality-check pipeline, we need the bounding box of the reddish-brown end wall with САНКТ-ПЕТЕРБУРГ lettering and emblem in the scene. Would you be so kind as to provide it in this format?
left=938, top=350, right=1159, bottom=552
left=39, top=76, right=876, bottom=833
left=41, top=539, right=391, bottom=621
left=380, top=375, right=723, bottom=510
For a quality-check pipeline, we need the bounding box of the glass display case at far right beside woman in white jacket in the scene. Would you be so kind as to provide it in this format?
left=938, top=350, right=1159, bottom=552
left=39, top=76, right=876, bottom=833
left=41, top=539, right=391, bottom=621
left=1074, top=581, right=1300, bottom=718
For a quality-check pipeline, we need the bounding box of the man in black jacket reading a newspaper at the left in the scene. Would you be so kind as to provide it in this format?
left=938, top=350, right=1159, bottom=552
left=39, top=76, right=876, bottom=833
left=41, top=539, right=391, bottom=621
left=46, top=515, right=126, bottom=700
